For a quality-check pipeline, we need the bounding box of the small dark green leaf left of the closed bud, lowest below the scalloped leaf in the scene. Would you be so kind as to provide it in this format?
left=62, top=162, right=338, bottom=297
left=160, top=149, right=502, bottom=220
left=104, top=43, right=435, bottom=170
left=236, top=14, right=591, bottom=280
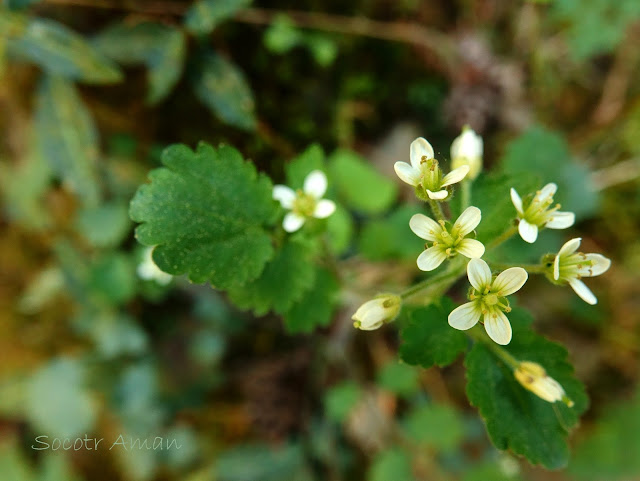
left=284, top=269, right=340, bottom=333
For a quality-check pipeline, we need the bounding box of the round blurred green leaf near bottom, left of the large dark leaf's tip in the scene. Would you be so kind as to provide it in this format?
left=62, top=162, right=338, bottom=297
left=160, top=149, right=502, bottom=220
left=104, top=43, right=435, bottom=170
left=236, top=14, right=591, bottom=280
left=404, top=404, right=464, bottom=451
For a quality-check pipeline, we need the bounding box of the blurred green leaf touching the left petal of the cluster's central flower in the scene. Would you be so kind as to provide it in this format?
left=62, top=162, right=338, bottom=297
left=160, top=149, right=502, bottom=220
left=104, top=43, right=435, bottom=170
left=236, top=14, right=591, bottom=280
left=358, top=205, right=424, bottom=261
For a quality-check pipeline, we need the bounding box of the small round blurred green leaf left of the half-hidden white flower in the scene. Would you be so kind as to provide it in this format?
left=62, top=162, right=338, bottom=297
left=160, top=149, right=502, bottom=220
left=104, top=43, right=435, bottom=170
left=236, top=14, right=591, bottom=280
left=87, top=252, right=136, bottom=305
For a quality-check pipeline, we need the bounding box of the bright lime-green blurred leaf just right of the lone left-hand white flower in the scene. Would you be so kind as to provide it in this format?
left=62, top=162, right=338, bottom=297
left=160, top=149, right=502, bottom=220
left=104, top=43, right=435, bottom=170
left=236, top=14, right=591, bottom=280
left=329, top=149, right=398, bottom=214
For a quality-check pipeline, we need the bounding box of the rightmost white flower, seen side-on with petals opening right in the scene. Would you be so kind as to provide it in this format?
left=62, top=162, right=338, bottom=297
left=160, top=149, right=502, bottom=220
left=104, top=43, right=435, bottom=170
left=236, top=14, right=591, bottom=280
left=553, top=237, right=611, bottom=305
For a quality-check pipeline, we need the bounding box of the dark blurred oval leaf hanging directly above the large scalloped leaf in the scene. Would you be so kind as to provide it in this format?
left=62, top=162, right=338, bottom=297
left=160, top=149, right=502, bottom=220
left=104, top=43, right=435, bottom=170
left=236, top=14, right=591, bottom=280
left=193, top=53, right=256, bottom=130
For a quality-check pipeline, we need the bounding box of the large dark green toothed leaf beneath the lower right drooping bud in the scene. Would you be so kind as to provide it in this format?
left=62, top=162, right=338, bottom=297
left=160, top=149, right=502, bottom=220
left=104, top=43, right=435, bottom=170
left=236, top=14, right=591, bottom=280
left=465, top=308, right=588, bottom=469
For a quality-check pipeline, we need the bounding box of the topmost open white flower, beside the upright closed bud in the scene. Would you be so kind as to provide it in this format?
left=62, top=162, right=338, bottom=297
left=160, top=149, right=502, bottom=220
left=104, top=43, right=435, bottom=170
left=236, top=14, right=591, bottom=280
left=393, top=137, right=469, bottom=200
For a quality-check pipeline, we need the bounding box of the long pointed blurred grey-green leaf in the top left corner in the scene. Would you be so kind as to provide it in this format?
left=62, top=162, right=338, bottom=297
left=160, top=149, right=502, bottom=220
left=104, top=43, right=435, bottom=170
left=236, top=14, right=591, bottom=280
left=8, top=18, right=122, bottom=83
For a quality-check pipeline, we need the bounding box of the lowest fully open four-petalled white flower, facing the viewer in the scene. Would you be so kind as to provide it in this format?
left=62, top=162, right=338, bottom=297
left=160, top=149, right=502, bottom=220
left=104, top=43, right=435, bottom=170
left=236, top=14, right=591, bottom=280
left=449, top=259, right=528, bottom=345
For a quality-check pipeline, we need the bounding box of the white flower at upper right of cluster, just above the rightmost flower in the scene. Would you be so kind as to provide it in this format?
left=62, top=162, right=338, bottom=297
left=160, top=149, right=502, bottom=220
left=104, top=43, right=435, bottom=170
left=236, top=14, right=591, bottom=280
left=511, top=183, right=576, bottom=244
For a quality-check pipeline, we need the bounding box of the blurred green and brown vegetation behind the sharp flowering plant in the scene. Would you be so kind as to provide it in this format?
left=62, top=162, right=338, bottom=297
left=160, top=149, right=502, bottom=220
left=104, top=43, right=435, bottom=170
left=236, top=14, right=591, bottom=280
left=0, top=0, right=640, bottom=481
